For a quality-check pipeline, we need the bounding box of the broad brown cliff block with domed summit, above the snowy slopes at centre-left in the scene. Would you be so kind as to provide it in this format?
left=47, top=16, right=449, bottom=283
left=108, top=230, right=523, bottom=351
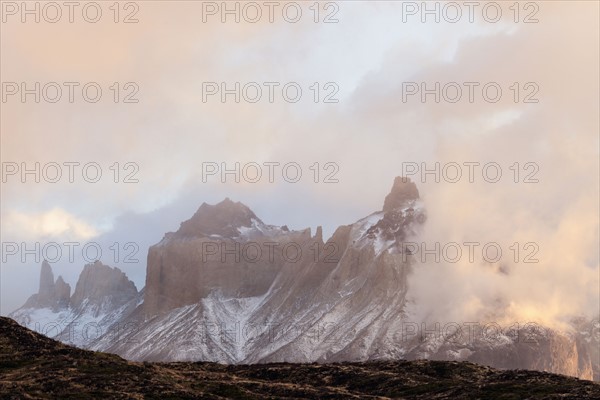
left=144, top=199, right=314, bottom=316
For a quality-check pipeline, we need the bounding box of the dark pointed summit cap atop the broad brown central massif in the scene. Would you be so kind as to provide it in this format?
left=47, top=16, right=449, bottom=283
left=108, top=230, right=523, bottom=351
left=175, top=197, right=262, bottom=237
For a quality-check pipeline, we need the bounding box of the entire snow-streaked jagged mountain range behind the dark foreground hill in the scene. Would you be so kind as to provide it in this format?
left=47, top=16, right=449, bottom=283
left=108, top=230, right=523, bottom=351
left=12, top=178, right=600, bottom=379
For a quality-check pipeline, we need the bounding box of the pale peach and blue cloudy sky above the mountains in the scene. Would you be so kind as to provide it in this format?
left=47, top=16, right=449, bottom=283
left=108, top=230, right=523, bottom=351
left=0, top=1, right=600, bottom=323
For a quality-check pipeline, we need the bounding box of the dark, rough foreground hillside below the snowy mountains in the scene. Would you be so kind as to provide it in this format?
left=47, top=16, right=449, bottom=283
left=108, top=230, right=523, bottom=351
left=0, top=317, right=600, bottom=399
